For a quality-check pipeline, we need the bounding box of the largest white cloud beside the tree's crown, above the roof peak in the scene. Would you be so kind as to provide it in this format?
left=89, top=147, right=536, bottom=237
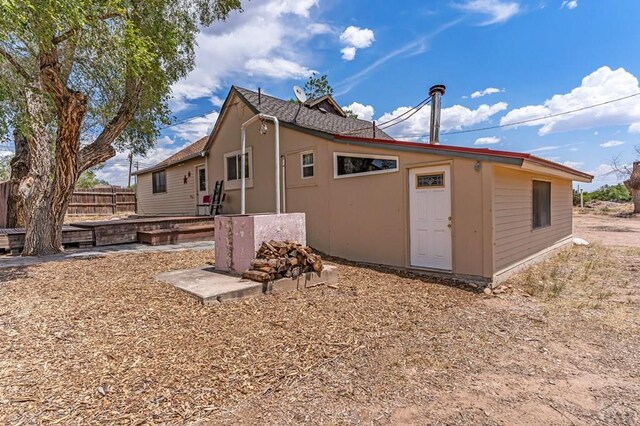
left=172, top=0, right=320, bottom=108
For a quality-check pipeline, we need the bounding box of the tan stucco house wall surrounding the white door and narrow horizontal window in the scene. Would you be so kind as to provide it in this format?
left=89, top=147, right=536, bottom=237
left=208, top=95, right=493, bottom=277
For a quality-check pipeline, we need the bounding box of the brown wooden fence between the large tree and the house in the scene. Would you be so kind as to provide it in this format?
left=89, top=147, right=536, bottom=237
left=67, top=188, right=136, bottom=215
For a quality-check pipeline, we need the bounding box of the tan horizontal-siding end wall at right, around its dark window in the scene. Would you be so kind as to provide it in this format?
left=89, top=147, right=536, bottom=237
left=494, top=167, right=572, bottom=271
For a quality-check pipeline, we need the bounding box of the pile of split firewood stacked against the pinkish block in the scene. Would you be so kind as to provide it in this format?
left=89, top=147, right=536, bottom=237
left=242, top=240, right=322, bottom=282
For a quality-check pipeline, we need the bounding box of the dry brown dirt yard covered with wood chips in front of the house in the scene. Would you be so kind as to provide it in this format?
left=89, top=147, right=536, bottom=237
left=0, top=218, right=640, bottom=425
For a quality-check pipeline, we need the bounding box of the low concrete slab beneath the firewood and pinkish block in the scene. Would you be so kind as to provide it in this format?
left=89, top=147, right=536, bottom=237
left=156, top=266, right=262, bottom=305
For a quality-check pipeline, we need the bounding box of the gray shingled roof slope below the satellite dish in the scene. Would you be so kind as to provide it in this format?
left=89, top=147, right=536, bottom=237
left=234, top=86, right=393, bottom=140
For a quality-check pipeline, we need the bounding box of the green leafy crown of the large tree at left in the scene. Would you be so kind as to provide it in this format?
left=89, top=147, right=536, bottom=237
left=0, top=0, right=241, bottom=155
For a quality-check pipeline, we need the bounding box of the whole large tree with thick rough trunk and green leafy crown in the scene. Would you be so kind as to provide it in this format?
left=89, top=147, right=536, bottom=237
left=0, top=0, right=241, bottom=255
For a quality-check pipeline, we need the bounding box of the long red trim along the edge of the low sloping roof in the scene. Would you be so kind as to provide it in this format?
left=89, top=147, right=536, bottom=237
left=334, top=135, right=593, bottom=179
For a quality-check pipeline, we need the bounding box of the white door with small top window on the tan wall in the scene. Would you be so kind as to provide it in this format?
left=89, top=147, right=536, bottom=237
left=409, top=165, right=452, bottom=271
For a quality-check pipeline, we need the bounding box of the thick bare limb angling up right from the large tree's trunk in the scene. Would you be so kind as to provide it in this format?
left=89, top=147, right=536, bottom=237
left=78, top=76, right=142, bottom=174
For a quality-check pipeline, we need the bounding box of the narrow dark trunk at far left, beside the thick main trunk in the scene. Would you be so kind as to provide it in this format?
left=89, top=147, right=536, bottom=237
left=7, top=130, right=29, bottom=228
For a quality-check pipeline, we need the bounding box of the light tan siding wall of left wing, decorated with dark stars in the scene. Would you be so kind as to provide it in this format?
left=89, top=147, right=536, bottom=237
left=136, top=158, right=206, bottom=216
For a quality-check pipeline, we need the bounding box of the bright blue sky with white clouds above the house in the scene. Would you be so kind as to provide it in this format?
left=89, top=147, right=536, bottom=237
left=2, top=0, right=640, bottom=189
